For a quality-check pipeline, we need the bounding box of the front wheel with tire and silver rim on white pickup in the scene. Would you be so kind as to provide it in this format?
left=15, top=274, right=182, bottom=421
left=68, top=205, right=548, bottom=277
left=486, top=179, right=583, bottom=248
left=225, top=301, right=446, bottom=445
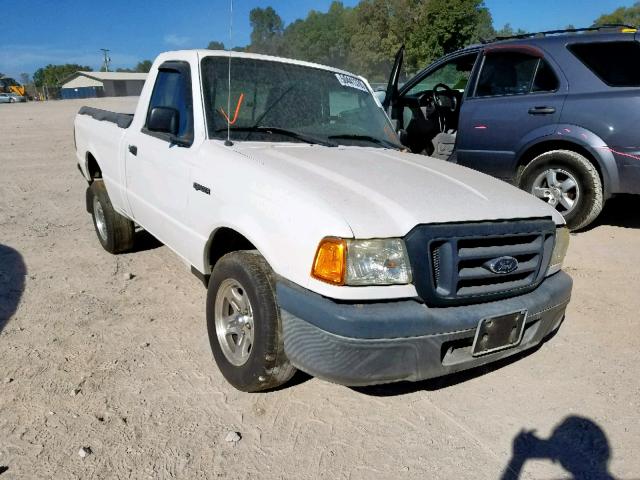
left=207, top=251, right=296, bottom=392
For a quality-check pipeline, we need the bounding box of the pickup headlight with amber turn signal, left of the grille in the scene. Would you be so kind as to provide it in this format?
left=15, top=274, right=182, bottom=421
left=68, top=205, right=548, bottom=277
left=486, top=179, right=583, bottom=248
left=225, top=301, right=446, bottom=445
left=311, top=237, right=411, bottom=286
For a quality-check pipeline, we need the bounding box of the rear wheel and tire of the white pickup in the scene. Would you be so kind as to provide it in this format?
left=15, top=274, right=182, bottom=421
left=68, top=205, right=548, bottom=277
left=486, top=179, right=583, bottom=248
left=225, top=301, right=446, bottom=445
left=89, top=180, right=135, bottom=254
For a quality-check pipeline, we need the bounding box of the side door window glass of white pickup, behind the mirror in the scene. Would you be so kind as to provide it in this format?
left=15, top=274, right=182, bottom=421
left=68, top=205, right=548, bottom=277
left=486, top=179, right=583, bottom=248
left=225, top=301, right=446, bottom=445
left=147, top=65, right=193, bottom=140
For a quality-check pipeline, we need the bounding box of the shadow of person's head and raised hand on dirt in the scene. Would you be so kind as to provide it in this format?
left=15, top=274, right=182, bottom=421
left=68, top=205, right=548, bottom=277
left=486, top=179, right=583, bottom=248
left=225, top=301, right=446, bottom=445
left=501, top=416, right=613, bottom=480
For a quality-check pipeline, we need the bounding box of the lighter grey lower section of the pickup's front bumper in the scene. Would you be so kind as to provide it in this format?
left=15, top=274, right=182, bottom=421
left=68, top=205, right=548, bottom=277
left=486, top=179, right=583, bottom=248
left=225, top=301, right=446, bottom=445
left=282, top=304, right=566, bottom=386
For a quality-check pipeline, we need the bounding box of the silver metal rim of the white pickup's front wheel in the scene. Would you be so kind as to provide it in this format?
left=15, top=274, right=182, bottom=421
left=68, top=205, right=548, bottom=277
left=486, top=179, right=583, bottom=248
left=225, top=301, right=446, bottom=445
left=214, top=279, right=253, bottom=367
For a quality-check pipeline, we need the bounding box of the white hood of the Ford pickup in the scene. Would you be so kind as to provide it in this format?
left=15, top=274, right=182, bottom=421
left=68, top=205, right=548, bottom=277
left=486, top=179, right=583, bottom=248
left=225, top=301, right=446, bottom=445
left=234, top=142, right=564, bottom=238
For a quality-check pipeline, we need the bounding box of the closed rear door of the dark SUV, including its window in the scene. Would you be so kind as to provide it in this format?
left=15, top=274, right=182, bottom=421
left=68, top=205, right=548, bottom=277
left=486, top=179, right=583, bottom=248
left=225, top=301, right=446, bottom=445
left=456, top=46, right=567, bottom=179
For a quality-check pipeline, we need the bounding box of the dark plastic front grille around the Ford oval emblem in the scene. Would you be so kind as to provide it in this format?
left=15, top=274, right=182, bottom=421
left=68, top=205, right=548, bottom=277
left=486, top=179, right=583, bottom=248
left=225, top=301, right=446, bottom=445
left=405, top=220, right=555, bottom=306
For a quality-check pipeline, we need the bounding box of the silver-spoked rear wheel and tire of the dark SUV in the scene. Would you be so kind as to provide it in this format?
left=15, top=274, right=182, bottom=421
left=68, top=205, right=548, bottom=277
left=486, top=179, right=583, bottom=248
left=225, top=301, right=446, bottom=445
left=518, top=150, right=604, bottom=230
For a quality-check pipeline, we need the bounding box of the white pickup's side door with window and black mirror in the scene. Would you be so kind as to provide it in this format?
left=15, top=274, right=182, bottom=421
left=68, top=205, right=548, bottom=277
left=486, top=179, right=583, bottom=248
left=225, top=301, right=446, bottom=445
left=125, top=62, right=195, bottom=251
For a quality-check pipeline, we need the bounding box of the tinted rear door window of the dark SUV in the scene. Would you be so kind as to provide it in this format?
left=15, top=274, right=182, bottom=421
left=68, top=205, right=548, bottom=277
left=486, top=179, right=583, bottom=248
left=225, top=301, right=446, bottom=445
left=475, top=52, right=559, bottom=97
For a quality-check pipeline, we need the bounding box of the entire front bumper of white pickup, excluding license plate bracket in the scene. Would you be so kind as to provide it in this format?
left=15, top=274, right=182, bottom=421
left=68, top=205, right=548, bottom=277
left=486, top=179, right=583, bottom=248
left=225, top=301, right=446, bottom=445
left=277, top=272, right=572, bottom=386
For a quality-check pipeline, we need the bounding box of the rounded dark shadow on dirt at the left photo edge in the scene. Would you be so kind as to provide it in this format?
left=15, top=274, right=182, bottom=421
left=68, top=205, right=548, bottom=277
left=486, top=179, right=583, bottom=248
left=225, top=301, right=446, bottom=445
left=0, top=244, right=27, bottom=332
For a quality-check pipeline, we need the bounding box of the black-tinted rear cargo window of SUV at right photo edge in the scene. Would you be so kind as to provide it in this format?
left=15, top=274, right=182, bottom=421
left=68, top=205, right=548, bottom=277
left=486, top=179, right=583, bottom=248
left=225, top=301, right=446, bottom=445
left=568, top=41, right=640, bottom=87
